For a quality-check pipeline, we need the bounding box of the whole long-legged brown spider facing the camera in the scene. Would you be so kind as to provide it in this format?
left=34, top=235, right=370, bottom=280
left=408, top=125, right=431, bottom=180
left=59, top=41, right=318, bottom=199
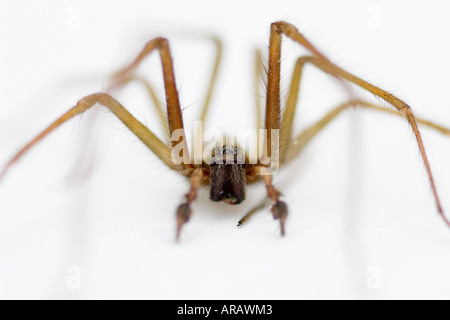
left=0, top=21, right=450, bottom=240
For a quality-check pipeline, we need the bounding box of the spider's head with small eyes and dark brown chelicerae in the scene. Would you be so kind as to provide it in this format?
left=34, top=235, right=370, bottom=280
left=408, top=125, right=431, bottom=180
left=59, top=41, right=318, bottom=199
left=209, top=145, right=245, bottom=204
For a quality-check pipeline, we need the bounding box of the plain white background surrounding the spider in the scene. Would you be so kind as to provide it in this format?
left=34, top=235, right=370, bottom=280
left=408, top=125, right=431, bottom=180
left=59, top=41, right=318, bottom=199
left=0, top=0, right=450, bottom=299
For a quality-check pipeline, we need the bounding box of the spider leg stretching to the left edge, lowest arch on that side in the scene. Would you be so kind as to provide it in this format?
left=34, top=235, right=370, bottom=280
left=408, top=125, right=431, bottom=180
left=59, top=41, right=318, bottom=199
left=0, top=93, right=184, bottom=179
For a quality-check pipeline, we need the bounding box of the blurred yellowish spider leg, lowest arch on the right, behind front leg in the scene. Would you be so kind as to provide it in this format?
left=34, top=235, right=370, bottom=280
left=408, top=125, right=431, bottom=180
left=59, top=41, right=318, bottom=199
left=285, top=100, right=450, bottom=163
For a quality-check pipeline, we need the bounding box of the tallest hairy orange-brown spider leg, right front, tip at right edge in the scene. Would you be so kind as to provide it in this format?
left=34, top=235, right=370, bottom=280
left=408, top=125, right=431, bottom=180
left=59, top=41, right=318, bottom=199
left=266, top=21, right=450, bottom=226
